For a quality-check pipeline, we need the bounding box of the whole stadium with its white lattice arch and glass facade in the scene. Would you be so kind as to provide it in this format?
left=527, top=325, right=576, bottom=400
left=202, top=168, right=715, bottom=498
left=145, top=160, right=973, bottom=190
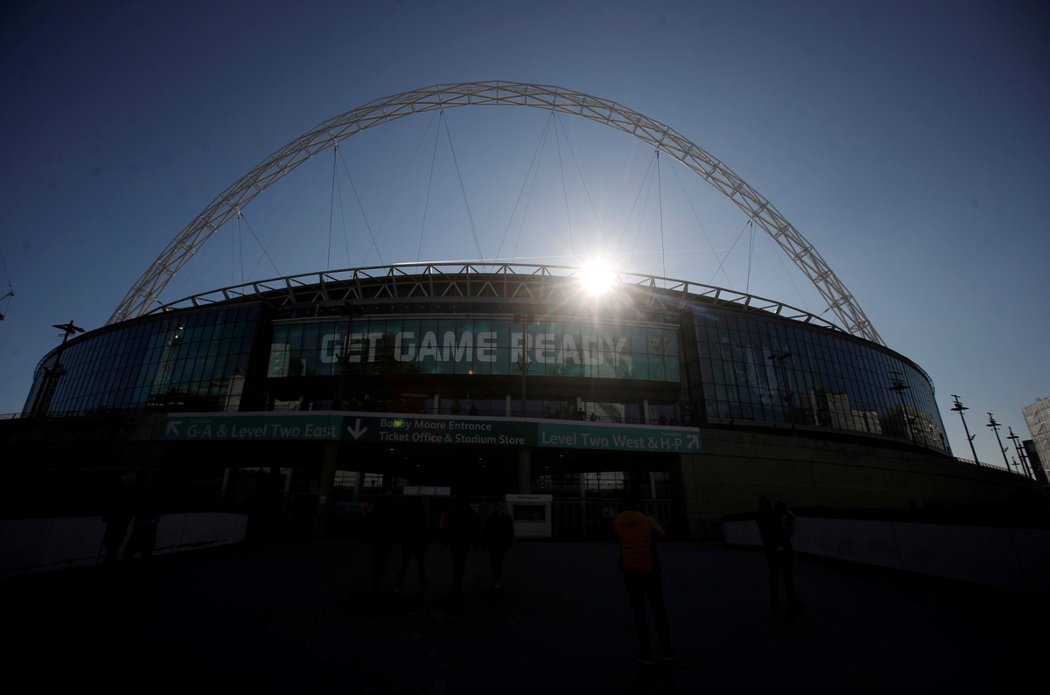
left=0, top=83, right=1040, bottom=539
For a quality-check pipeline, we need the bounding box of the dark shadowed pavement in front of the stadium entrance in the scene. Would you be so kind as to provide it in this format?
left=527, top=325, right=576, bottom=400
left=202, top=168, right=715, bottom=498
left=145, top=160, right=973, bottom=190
left=2, top=541, right=1050, bottom=695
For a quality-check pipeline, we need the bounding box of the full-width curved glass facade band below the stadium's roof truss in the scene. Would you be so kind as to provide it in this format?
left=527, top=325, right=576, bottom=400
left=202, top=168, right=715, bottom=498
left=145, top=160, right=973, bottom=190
left=27, top=285, right=947, bottom=450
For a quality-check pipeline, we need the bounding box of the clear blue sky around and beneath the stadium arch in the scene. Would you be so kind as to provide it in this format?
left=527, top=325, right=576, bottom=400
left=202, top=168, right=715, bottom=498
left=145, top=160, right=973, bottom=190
left=0, top=0, right=1050, bottom=474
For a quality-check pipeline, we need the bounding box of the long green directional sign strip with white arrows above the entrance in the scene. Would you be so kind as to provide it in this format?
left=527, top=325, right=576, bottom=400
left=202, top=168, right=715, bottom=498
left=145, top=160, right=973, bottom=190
left=164, top=413, right=700, bottom=454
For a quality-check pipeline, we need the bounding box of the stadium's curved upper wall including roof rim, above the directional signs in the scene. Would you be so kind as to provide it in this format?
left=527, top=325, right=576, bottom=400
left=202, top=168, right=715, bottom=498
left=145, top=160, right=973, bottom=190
left=26, top=266, right=947, bottom=443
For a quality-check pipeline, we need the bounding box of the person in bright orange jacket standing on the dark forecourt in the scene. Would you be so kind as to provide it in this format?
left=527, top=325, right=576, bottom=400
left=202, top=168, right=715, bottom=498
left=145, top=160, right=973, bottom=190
left=612, top=494, right=677, bottom=665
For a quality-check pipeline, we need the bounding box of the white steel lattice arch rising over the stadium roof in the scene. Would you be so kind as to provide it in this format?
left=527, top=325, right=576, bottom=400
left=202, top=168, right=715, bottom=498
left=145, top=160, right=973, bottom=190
left=108, top=82, right=884, bottom=344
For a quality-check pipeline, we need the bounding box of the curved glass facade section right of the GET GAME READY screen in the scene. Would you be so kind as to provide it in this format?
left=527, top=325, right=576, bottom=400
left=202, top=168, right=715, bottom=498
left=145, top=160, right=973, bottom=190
left=692, top=307, right=947, bottom=450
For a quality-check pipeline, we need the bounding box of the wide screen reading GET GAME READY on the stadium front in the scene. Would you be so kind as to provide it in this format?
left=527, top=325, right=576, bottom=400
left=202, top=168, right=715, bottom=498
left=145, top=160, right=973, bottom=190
left=267, top=317, right=680, bottom=381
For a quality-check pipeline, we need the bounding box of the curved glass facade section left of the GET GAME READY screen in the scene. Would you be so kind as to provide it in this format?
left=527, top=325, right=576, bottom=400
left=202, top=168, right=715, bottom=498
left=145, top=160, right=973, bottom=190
left=30, top=307, right=259, bottom=415
